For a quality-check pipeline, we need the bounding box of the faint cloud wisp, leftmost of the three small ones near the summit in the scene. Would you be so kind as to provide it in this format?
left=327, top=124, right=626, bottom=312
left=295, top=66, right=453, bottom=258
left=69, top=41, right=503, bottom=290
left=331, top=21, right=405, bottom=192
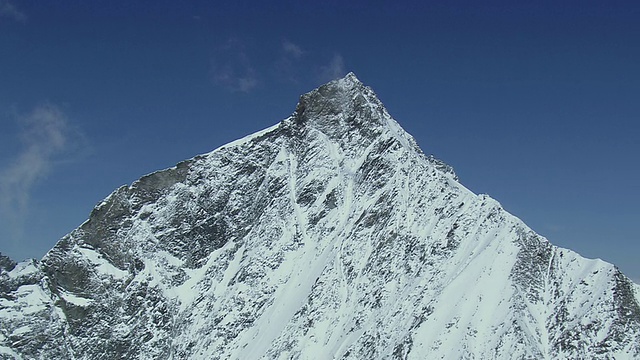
left=211, top=39, right=259, bottom=93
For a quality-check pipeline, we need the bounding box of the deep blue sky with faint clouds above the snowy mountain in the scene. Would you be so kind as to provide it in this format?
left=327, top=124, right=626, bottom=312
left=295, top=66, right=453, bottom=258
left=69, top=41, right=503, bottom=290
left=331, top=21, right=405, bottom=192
left=0, top=0, right=640, bottom=281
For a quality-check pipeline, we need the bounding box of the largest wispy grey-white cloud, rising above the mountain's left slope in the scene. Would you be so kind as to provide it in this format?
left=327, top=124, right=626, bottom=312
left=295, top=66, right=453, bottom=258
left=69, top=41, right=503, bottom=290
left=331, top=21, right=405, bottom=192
left=0, top=103, right=75, bottom=238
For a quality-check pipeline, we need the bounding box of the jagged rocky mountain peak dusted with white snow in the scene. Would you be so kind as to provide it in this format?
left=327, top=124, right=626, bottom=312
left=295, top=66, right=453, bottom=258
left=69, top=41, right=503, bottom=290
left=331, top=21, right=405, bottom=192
left=0, top=74, right=640, bottom=359
